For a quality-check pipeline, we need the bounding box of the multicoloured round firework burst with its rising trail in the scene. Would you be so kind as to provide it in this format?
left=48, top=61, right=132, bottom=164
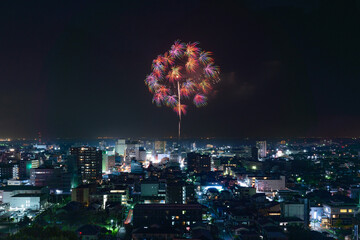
left=145, top=40, right=220, bottom=137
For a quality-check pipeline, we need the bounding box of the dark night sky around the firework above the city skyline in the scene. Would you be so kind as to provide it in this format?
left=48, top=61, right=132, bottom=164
left=0, top=0, right=360, bottom=138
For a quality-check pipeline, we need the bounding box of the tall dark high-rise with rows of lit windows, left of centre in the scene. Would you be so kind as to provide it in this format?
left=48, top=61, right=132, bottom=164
left=70, top=147, right=102, bottom=183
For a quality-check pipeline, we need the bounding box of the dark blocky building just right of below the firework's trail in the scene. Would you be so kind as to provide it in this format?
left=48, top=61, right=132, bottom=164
left=187, top=152, right=211, bottom=173
